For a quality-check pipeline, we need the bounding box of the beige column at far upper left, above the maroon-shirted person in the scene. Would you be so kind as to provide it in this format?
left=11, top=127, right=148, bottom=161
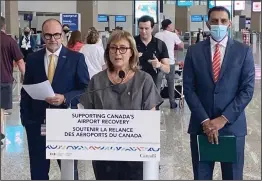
left=5, top=1, right=19, bottom=36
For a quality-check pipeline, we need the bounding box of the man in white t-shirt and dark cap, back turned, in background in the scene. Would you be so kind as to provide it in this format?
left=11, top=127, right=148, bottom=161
left=155, top=19, right=184, bottom=109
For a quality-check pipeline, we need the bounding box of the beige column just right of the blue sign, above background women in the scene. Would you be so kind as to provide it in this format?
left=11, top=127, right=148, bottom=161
left=76, top=0, right=98, bottom=37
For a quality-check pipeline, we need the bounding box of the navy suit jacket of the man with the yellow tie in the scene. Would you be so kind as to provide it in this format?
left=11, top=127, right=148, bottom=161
left=20, top=47, right=89, bottom=125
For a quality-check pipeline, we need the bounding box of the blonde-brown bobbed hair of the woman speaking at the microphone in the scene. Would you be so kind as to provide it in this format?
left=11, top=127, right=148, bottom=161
left=104, top=30, right=139, bottom=72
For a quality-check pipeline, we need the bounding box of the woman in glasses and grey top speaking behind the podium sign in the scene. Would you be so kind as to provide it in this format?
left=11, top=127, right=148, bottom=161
left=80, top=30, right=163, bottom=180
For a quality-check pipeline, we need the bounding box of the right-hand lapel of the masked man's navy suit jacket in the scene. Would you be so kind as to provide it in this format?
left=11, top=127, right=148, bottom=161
left=218, top=38, right=234, bottom=80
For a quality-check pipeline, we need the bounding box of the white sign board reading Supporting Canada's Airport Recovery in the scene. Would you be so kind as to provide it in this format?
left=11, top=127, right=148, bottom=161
left=46, top=109, right=160, bottom=161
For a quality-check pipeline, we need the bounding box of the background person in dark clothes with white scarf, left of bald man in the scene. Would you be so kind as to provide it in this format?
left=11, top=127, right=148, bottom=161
left=19, top=27, right=36, bottom=62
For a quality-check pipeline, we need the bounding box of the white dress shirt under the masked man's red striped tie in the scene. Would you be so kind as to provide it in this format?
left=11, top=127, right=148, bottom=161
left=210, top=36, right=228, bottom=67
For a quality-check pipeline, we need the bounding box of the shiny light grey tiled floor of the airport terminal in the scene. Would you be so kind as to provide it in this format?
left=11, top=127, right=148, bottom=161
left=1, top=43, right=261, bottom=180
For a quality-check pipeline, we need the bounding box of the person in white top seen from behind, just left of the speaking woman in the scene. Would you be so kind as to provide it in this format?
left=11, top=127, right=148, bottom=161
left=80, top=30, right=106, bottom=78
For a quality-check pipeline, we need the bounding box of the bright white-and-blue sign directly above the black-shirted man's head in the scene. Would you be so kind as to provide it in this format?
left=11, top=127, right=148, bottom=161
left=134, top=1, right=158, bottom=23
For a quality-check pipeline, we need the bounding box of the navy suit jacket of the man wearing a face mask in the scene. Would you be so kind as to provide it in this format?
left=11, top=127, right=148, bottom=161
left=183, top=38, right=255, bottom=136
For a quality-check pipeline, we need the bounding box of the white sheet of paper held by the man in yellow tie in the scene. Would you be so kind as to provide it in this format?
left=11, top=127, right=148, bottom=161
left=23, top=80, right=55, bottom=100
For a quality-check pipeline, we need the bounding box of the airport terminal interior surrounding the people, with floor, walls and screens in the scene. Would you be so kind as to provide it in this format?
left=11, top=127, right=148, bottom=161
left=1, top=0, right=261, bottom=180
